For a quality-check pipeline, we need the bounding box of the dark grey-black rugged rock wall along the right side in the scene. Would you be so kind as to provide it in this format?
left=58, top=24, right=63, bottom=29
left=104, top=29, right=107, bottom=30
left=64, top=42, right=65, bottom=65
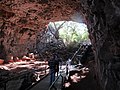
left=81, top=0, right=120, bottom=90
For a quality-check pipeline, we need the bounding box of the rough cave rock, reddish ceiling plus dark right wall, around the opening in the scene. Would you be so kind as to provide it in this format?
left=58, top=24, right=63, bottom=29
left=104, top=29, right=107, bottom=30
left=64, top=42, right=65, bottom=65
left=0, top=0, right=120, bottom=90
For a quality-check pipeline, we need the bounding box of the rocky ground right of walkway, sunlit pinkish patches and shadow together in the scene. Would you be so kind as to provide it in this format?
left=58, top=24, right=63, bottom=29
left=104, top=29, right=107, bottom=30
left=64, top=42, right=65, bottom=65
left=63, top=61, right=102, bottom=90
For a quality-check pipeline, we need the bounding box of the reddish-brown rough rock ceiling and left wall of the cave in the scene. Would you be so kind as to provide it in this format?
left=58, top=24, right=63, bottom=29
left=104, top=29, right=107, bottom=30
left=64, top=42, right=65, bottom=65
left=0, top=0, right=80, bottom=59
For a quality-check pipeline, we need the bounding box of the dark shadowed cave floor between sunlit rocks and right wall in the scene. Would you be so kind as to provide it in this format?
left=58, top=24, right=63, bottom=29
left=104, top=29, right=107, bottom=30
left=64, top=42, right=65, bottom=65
left=63, top=62, right=102, bottom=90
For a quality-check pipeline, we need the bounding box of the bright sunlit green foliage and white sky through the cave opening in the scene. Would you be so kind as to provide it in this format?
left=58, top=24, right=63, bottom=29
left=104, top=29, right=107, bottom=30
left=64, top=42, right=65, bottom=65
left=48, top=21, right=90, bottom=46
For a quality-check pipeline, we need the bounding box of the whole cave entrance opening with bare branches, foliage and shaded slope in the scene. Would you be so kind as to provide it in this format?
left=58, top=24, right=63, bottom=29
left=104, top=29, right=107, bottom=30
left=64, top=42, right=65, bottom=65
left=36, top=21, right=91, bottom=61
